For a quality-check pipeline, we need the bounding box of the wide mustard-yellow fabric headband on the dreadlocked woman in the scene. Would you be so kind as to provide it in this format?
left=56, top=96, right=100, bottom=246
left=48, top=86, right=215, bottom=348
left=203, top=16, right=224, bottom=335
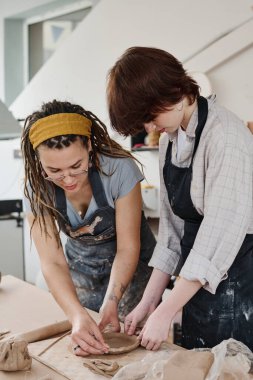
left=29, top=113, right=92, bottom=149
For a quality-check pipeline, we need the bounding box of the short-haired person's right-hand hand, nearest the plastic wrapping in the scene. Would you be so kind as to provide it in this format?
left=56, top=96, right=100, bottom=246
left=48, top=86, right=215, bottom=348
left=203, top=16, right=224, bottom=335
left=138, top=303, right=172, bottom=351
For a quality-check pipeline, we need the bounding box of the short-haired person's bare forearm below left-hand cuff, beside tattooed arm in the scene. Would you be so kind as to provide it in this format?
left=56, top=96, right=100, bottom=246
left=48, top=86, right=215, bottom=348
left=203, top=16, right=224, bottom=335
left=142, top=268, right=171, bottom=307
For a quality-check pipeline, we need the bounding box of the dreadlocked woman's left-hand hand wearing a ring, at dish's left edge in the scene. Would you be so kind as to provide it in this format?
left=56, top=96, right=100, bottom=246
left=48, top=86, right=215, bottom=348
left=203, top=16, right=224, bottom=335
left=71, top=310, right=109, bottom=356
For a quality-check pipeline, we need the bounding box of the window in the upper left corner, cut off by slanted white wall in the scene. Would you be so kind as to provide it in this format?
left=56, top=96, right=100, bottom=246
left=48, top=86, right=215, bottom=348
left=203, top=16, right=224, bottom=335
left=4, top=0, right=94, bottom=106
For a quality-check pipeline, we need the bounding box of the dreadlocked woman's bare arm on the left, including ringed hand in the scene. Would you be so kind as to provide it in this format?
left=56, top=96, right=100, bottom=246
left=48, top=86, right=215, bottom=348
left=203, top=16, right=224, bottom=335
left=27, top=213, right=107, bottom=355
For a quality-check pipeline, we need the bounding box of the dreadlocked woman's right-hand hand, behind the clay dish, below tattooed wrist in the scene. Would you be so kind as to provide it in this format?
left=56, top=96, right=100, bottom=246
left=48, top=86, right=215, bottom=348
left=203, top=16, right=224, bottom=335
left=98, top=300, right=120, bottom=332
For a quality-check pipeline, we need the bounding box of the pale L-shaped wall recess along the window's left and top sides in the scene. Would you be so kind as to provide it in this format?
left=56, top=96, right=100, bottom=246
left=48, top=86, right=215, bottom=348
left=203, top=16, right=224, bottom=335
left=0, top=0, right=95, bottom=105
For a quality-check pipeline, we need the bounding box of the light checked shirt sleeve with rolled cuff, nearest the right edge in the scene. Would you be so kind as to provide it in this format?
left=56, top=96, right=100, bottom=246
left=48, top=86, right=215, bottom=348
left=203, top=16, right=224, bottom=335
left=180, top=120, right=252, bottom=294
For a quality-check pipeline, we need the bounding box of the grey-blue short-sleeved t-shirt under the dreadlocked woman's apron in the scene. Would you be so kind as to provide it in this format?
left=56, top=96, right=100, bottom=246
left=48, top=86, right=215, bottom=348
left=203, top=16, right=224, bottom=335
left=24, top=155, right=144, bottom=228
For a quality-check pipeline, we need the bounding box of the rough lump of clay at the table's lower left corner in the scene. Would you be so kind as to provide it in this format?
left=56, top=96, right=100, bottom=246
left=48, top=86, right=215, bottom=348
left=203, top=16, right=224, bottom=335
left=0, top=339, right=32, bottom=371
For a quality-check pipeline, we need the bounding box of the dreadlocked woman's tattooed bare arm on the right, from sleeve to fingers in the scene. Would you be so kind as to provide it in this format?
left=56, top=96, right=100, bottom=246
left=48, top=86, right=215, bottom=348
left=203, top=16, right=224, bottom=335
left=99, top=182, right=142, bottom=331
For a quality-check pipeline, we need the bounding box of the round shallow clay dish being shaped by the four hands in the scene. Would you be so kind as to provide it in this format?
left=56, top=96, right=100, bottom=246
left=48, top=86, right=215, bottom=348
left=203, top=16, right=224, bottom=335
left=103, top=332, right=140, bottom=354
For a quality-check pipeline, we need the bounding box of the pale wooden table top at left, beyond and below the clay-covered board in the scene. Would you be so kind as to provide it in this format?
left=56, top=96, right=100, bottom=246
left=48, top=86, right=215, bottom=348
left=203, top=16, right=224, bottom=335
left=0, top=276, right=70, bottom=380
